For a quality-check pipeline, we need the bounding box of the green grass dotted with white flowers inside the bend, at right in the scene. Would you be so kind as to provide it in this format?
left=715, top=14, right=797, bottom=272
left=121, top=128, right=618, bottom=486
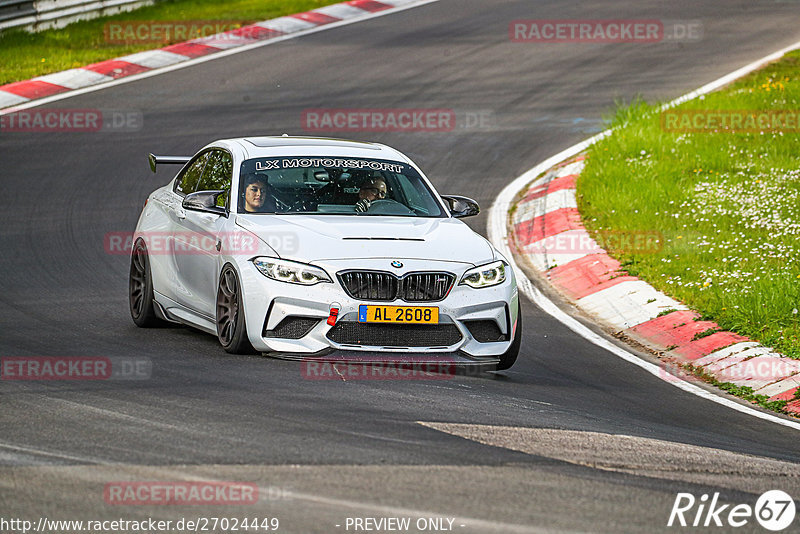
left=578, top=53, right=800, bottom=358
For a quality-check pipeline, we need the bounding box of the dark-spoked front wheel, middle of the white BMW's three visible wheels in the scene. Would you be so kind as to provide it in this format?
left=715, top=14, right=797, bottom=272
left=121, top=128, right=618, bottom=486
left=217, top=265, right=255, bottom=354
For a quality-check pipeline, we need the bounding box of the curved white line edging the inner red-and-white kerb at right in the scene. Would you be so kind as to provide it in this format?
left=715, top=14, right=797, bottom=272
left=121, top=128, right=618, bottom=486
left=488, top=42, right=800, bottom=430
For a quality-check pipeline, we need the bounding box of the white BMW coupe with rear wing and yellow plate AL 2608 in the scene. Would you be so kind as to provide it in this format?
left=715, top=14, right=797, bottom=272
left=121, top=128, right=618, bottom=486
left=129, top=136, right=522, bottom=369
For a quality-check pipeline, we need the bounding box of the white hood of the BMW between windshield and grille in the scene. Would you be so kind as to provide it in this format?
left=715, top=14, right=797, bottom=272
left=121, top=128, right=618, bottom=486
left=236, top=214, right=495, bottom=265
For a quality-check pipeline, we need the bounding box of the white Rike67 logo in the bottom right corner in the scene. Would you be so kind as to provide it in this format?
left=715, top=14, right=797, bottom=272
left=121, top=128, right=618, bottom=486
left=667, top=490, right=795, bottom=532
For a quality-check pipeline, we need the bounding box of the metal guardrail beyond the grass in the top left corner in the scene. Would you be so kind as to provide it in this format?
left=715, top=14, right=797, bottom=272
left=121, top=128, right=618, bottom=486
left=0, top=0, right=154, bottom=31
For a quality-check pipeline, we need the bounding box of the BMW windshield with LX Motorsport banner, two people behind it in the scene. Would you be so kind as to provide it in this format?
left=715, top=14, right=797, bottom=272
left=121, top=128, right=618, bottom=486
left=239, top=156, right=446, bottom=217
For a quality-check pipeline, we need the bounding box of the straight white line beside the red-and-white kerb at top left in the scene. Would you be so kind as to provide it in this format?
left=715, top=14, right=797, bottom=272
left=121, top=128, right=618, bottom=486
left=0, top=0, right=439, bottom=115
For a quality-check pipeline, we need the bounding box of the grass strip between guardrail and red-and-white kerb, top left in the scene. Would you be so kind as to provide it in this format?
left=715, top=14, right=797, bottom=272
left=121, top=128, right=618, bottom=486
left=0, top=0, right=341, bottom=85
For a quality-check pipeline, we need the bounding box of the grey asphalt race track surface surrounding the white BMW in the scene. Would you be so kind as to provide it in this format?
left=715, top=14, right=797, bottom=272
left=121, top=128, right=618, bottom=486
left=0, top=0, right=800, bottom=533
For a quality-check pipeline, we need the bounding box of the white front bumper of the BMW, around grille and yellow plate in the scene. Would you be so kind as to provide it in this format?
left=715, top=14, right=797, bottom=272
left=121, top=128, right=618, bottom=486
left=239, top=259, right=519, bottom=363
